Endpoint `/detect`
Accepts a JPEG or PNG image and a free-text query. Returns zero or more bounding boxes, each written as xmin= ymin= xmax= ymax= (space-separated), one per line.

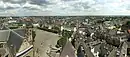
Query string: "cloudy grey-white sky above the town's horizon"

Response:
xmin=0 ymin=0 xmax=130 ymax=16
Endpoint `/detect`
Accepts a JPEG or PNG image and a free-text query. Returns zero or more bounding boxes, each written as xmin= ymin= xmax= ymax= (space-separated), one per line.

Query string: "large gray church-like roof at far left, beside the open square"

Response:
xmin=0 ymin=29 xmax=25 ymax=53
